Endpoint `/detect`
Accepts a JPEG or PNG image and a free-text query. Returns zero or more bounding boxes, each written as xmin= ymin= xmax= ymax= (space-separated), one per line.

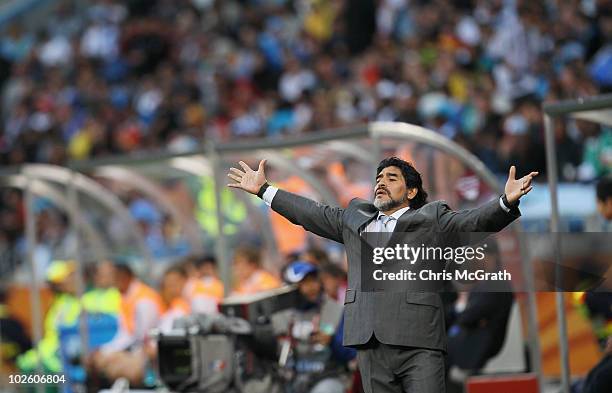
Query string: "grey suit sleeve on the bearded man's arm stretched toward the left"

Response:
xmin=272 ymin=190 xmax=344 ymax=243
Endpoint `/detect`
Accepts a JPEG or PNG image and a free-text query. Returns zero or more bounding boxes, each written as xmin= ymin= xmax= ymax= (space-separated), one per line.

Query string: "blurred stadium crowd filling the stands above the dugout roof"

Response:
xmin=0 ymin=0 xmax=612 ymax=181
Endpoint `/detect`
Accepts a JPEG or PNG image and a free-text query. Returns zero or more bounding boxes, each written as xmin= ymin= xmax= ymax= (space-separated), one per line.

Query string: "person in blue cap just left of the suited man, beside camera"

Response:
xmin=272 ymin=261 xmax=355 ymax=393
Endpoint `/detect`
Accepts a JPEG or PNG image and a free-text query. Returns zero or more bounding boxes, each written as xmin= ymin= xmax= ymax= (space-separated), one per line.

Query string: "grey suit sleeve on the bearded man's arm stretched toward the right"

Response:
xmin=437 ymin=199 xmax=521 ymax=232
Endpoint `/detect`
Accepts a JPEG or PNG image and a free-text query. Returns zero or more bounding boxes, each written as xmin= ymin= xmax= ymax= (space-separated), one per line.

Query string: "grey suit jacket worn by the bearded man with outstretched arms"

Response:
xmin=272 ymin=190 xmax=520 ymax=350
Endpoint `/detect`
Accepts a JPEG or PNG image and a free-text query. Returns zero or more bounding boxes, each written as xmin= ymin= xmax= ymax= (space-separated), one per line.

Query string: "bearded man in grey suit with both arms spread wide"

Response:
xmin=228 ymin=157 xmax=538 ymax=393
